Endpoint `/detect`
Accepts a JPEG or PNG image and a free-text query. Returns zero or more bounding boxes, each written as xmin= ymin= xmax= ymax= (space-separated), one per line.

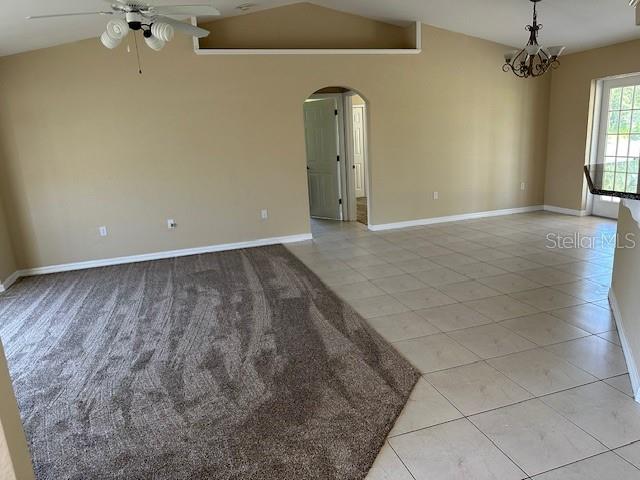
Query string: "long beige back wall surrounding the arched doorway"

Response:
xmin=0 ymin=6 xmax=550 ymax=268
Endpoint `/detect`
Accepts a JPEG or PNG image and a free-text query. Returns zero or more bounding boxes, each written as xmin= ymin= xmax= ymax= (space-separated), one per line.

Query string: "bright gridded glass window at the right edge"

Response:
xmin=595 ymin=75 xmax=640 ymax=195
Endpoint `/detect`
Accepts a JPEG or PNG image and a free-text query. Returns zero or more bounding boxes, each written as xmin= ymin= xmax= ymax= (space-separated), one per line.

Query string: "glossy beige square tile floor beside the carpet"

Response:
xmin=290 ymin=212 xmax=640 ymax=480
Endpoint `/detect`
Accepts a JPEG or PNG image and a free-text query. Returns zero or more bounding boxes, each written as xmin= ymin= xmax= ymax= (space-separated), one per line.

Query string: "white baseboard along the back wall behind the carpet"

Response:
xmin=0 ymin=233 xmax=313 ymax=292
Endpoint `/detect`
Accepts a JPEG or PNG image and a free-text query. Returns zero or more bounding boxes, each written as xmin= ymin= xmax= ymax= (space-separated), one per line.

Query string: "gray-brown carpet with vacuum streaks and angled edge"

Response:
xmin=0 ymin=246 xmax=418 ymax=480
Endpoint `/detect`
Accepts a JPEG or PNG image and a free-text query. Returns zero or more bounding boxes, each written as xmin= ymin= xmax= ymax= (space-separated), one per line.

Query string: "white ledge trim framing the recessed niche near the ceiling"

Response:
xmin=191 ymin=17 xmax=422 ymax=55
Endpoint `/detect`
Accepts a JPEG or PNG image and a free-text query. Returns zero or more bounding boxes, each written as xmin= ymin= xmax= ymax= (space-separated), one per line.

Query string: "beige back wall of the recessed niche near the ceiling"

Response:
xmin=200 ymin=3 xmax=416 ymax=49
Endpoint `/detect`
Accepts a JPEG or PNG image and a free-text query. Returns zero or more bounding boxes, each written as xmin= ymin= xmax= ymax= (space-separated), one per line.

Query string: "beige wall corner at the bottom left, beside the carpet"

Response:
xmin=0 ymin=342 xmax=35 ymax=480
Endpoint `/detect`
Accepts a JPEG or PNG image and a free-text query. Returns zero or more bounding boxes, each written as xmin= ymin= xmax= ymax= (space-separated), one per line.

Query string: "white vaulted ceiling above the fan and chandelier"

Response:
xmin=0 ymin=0 xmax=640 ymax=55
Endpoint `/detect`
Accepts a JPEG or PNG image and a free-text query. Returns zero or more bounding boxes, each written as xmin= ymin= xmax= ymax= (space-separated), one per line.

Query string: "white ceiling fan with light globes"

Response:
xmin=27 ymin=0 xmax=220 ymax=50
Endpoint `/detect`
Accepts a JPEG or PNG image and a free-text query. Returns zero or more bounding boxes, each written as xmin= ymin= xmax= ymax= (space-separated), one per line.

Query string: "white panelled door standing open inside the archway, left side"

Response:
xmin=304 ymin=98 xmax=342 ymax=220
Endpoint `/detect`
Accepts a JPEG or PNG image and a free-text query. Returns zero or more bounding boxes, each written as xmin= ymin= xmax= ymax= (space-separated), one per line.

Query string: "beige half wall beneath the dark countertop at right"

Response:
xmin=611 ymin=205 xmax=640 ymax=393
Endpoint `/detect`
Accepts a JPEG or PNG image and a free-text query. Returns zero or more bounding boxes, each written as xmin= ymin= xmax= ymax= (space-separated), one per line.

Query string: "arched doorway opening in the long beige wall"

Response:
xmin=304 ymin=87 xmax=371 ymax=226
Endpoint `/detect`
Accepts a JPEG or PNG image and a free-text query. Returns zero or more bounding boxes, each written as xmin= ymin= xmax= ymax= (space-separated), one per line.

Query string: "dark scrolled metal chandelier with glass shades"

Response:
xmin=502 ymin=0 xmax=565 ymax=78
